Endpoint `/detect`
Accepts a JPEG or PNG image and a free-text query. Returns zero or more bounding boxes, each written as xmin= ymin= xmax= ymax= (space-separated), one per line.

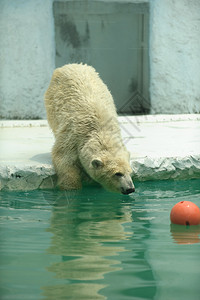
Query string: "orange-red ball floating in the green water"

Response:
xmin=170 ymin=201 xmax=200 ymax=225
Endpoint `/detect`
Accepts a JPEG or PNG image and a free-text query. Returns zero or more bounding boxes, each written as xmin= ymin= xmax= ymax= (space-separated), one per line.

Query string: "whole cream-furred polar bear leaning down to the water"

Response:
xmin=45 ymin=64 xmax=135 ymax=194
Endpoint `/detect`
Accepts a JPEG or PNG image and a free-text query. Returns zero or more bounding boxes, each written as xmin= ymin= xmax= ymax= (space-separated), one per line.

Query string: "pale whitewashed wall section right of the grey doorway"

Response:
xmin=150 ymin=0 xmax=200 ymax=114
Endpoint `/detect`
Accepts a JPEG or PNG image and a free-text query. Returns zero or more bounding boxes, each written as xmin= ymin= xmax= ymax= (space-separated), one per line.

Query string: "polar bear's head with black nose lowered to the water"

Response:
xmin=87 ymin=155 xmax=135 ymax=195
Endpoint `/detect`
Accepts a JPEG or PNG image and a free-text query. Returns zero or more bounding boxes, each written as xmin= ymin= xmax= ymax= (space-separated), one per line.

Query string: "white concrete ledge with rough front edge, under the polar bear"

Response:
xmin=0 ymin=114 xmax=200 ymax=190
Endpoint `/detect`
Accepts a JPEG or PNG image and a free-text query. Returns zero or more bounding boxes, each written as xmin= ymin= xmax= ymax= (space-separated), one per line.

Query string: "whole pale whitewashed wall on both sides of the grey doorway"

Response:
xmin=0 ymin=0 xmax=200 ymax=119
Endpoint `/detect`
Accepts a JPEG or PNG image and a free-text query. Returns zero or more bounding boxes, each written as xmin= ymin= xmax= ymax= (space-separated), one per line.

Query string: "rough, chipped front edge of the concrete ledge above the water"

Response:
xmin=0 ymin=156 xmax=200 ymax=191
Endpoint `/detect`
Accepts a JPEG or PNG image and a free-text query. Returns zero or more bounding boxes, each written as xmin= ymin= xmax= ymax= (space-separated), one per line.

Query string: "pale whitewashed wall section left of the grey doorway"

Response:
xmin=0 ymin=0 xmax=55 ymax=119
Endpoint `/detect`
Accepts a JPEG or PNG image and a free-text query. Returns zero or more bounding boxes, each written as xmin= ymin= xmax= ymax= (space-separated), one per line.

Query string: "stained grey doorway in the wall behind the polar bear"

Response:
xmin=53 ymin=0 xmax=150 ymax=114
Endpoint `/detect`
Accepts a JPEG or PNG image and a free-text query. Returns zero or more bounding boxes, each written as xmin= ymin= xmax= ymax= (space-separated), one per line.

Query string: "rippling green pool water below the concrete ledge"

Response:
xmin=0 ymin=180 xmax=200 ymax=300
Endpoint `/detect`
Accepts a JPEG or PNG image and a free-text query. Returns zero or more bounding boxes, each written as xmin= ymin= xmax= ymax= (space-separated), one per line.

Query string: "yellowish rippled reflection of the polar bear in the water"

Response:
xmin=43 ymin=189 xmax=132 ymax=300
